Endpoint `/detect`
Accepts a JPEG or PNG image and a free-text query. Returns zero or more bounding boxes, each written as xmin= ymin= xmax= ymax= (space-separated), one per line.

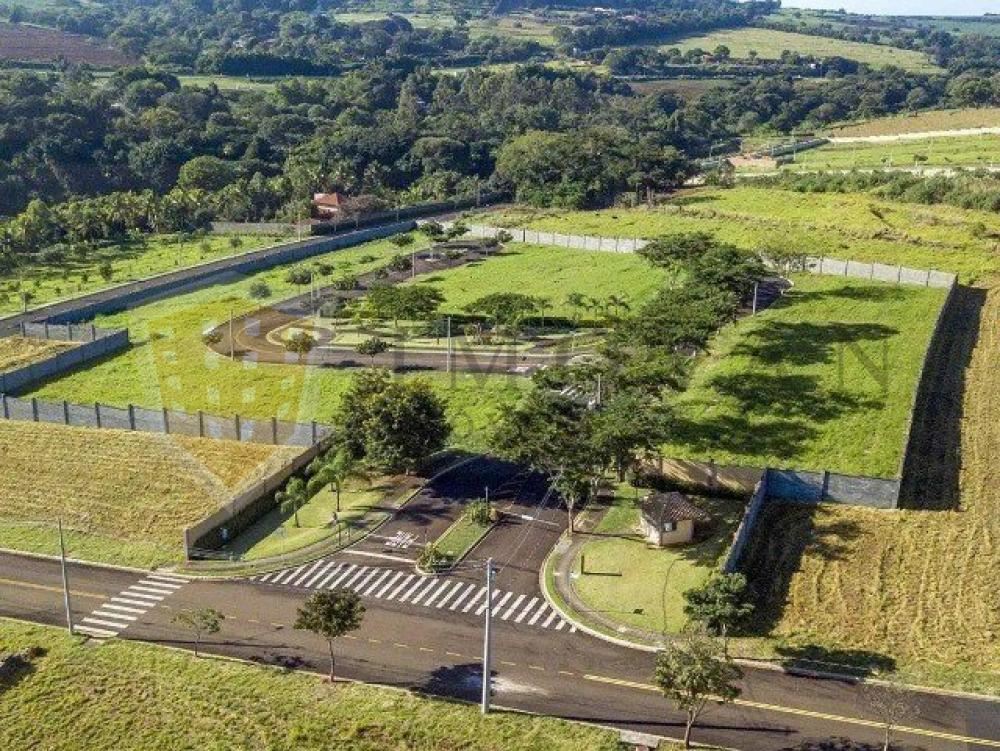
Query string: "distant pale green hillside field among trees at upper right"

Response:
xmin=660 ymin=28 xmax=940 ymax=73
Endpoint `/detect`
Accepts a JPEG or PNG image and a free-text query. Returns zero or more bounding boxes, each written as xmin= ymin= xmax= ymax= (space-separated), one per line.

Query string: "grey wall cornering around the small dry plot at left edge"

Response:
xmin=0 ymin=323 xmax=129 ymax=393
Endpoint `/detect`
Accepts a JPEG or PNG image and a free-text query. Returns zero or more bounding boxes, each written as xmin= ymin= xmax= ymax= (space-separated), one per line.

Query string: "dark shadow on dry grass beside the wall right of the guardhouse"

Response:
xmin=740 ymin=503 xmax=861 ymax=636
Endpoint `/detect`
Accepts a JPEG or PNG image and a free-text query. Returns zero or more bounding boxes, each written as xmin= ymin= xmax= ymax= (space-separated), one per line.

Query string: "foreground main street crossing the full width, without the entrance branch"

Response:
xmin=0 ymin=554 xmax=1000 ymax=751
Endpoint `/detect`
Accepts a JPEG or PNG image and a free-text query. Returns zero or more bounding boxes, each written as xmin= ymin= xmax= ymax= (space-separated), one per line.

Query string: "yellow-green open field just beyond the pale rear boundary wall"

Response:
xmin=477 ymin=186 xmax=1000 ymax=283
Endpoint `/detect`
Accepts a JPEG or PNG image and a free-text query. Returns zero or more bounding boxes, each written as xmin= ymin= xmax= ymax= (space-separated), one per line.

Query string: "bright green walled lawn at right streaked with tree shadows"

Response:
xmin=663 ymin=274 xmax=945 ymax=477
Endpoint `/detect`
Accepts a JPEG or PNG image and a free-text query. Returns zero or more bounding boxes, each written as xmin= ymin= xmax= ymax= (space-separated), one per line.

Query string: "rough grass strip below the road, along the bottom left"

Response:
xmin=0 ymin=620 xmax=618 ymax=751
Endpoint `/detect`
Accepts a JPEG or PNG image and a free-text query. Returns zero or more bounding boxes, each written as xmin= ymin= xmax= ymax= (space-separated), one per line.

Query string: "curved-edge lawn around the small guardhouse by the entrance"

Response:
xmin=572 ymin=485 xmax=744 ymax=633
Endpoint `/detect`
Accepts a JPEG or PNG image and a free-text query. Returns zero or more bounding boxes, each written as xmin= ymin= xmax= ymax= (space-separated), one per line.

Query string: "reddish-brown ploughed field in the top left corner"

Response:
xmin=0 ymin=23 xmax=135 ymax=68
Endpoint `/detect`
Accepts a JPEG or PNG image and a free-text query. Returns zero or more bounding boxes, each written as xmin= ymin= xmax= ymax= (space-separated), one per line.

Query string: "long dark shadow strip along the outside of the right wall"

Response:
xmin=900 ymin=287 xmax=986 ymax=511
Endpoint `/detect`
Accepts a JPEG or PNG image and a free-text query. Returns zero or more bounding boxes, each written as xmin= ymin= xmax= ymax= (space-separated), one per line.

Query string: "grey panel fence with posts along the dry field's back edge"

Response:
xmin=0 ymin=394 xmax=333 ymax=447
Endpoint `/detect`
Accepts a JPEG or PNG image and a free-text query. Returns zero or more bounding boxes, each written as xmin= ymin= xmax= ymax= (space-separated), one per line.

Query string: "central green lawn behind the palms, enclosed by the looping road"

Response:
xmin=406 ymin=243 xmax=667 ymax=319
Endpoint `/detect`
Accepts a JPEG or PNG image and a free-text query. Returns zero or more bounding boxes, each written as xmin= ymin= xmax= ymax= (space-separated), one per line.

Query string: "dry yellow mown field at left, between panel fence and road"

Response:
xmin=0 ymin=421 xmax=301 ymax=567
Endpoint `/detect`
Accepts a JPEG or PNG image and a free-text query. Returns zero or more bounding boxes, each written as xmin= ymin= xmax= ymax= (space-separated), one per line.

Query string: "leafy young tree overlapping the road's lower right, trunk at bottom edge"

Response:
xmin=653 ymin=633 xmax=743 ymax=748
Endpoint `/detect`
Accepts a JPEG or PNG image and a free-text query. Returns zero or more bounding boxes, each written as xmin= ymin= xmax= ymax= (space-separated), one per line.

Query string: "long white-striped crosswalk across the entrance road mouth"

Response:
xmin=252 ymin=558 xmax=576 ymax=634
